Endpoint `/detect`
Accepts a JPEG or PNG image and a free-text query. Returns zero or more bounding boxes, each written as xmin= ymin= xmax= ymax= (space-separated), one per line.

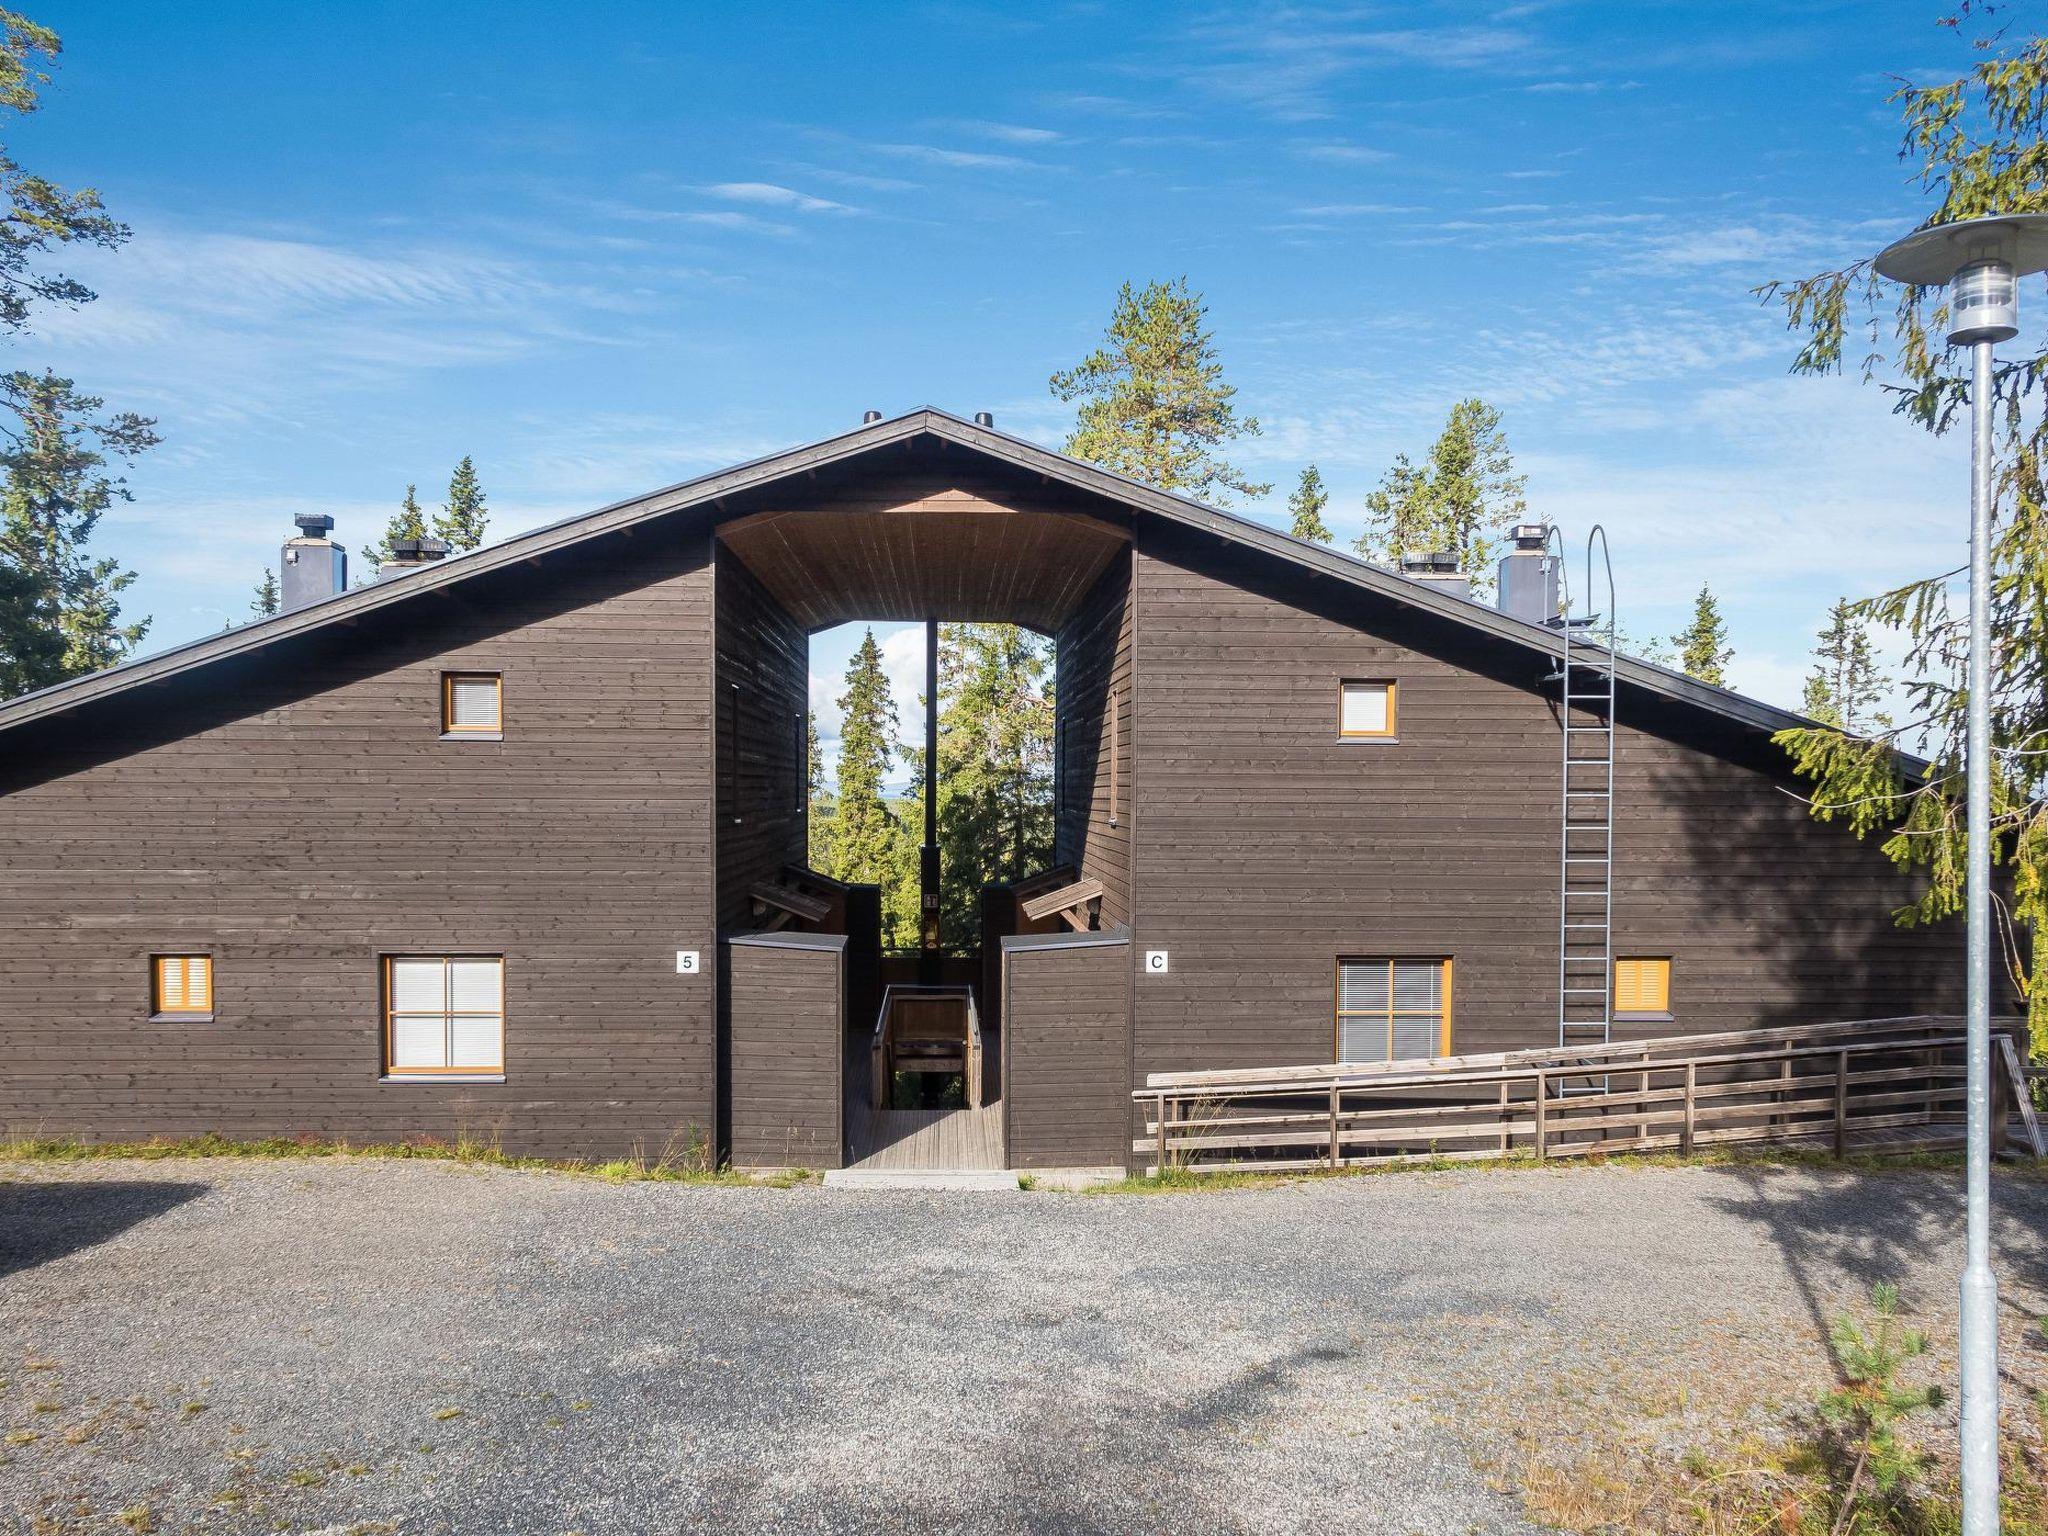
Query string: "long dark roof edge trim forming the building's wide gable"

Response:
xmin=0 ymin=406 xmax=1812 ymax=745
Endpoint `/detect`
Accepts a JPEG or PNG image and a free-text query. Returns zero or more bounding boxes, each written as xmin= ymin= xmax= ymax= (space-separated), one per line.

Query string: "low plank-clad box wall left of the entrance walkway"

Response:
xmin=725 ymin=934 xmax=846 ymax=1167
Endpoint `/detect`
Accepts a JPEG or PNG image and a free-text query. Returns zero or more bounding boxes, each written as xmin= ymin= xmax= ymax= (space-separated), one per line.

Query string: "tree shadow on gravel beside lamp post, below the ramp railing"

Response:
xmin=1712 ymin=1167 xmax=2048 ymax=1368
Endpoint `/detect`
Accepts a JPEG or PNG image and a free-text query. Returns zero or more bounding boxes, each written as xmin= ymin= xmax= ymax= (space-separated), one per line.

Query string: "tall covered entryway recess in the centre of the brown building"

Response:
xmin=715 ymin=436 xmax=1130 ymax=1171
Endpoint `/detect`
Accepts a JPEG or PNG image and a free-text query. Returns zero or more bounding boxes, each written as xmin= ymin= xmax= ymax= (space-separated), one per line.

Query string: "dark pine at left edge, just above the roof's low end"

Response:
xmin=0 ymin=373 xmax=158 ymax=692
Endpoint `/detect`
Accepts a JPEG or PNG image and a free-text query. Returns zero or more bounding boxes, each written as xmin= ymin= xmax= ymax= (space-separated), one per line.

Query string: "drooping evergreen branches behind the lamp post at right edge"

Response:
xmin=1757 ymin=4 xmax=2048 ymax=1057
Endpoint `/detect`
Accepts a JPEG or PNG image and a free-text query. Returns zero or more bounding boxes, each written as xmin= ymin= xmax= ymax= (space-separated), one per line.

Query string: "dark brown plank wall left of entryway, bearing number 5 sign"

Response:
xmin=0 ymin=524 xmax=717 ymax=1157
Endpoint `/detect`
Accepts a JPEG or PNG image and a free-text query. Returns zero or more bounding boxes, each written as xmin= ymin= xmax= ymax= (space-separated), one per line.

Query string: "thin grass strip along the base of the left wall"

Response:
xmin=0 ymin=1133 xmax=815 ymax=1190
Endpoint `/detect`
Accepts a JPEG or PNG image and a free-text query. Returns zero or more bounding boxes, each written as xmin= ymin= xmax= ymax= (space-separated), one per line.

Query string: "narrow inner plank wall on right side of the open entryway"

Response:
xmin=1053 ymin=555 xmax=1135 ymax=926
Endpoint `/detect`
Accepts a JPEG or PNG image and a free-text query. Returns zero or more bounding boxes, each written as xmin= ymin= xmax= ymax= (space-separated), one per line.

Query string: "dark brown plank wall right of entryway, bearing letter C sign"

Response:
xmin=1133 ymin=524 xmax=1962 ymax=1105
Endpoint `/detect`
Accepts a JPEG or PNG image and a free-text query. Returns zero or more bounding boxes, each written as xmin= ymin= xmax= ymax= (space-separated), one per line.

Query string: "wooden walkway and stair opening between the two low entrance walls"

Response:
xmin=846 ymin=985 xmax=1004 ymax=1169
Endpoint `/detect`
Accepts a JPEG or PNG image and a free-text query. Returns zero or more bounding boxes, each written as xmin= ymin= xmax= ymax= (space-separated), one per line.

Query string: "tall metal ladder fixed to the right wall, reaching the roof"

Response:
xmin=1546 ymin=524 xmax=1616 ymax=1094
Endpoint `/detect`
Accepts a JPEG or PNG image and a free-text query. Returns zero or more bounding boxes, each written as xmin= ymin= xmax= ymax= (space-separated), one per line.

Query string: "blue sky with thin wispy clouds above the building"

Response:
xmin=12 ymin=0 xmax=1998 ymax=770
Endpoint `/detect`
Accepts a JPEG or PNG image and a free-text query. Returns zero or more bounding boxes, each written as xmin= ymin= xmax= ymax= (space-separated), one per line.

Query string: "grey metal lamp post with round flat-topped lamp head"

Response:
xmin=1876 ymin=213 xmax=2048 ymax=1536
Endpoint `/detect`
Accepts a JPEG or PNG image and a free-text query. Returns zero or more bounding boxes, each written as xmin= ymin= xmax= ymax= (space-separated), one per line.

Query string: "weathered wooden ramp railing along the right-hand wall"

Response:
xmin=1133 ymin=1016 xmax=2042 ymax=1171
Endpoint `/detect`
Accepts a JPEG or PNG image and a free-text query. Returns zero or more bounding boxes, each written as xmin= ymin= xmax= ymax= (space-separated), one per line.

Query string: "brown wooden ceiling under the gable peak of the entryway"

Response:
xmin=719 ymin=473 xmax=1130 ymax=633
